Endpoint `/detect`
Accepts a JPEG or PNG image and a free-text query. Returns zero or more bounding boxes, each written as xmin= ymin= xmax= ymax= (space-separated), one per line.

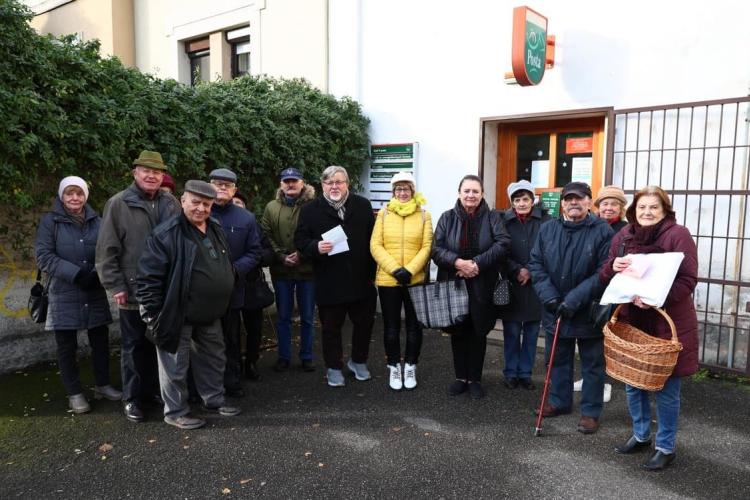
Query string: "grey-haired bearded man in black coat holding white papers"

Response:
xmin=294 ymin=166 xmax=377 ymax=387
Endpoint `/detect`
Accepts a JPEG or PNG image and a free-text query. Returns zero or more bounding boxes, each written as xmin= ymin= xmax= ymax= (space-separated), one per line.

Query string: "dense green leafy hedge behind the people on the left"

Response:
xmin=0 ymin=0 xmax=369 ymax=262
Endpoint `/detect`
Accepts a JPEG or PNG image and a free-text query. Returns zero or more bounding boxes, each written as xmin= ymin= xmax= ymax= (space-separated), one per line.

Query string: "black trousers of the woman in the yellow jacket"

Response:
xmin=378 ymin=286 xmax=422 ymax=365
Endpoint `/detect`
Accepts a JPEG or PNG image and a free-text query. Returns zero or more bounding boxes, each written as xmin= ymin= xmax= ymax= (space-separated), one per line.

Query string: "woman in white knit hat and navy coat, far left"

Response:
xmin=34 ymin=176 xmax=122 ymax=413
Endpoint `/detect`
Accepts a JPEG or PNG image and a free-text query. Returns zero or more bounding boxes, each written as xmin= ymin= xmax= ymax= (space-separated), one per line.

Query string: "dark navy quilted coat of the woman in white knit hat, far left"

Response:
xmin=34 ymin=199 xmax=112 ymax=330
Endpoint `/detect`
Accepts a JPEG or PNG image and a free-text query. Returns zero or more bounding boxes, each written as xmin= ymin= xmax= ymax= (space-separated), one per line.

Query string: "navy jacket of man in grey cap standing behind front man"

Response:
xmin=211 ymin=202 xmax=263 ymax=309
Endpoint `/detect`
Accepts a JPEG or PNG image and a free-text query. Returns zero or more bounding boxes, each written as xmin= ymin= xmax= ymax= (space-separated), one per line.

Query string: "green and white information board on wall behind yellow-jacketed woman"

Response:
xmin=370 ymin=142 xmax=419 ymax=211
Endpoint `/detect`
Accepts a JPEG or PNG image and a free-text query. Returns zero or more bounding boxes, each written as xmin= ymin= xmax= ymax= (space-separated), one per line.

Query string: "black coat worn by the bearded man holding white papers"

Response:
xmin=294 ymin=192 xmax=377 ymax=306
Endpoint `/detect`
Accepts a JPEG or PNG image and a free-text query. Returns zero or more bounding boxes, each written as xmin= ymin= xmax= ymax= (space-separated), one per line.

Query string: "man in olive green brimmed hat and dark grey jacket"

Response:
xmin=96 ymin=151 xmax=180 ymax=422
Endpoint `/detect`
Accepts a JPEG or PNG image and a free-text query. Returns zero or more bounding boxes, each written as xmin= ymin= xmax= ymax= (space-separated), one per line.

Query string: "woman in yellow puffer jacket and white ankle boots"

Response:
xmin=370 ymin=172 xmax=432 ymax=391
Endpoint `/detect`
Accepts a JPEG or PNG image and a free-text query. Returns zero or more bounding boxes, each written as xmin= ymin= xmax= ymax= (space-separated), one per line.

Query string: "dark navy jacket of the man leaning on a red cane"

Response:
xmin=529 ymin=212 xmax=614 ymax=338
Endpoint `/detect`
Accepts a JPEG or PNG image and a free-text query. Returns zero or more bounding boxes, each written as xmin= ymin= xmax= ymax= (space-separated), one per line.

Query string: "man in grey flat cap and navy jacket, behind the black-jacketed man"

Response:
xmin=208 ymin=168 xmax=263 ymax=398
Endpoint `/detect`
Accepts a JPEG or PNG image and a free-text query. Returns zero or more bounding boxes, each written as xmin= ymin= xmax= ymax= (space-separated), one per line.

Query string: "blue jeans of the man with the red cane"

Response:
xmin=546 ymin=333 xmax=605 ymax=418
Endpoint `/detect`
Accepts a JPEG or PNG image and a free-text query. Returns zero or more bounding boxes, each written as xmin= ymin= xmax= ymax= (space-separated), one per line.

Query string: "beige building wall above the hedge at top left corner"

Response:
xmin=31 ymin=0 xmax=136 ymax=66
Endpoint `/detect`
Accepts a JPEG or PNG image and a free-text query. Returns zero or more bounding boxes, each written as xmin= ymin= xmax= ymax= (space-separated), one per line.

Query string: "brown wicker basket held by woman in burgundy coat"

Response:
xmin=603 ymin=304 xmax=682 ymax=391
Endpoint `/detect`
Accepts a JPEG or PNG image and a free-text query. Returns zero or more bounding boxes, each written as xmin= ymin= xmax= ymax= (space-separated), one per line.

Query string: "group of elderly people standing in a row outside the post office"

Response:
xmin=35 ymin=159 xmax=698 ymax=470
